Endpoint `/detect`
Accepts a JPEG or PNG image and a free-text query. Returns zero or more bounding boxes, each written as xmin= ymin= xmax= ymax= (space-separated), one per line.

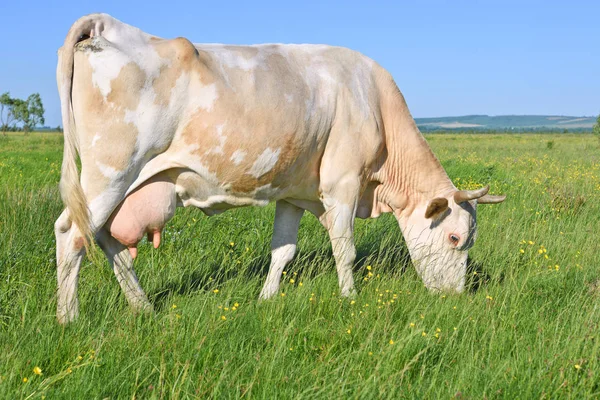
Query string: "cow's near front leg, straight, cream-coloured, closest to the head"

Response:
xmin=319 ymin=177 xmax=359 ymax=297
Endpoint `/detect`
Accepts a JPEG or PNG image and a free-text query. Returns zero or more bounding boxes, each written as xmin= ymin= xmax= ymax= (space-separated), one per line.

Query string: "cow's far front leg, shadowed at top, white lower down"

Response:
xmin=260 ymin=200 xmax=304 ymax=299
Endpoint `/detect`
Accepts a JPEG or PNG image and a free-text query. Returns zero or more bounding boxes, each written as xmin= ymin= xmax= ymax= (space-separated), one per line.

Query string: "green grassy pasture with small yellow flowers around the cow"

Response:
xmin=0 ymin=133 xmax=600 ymax=399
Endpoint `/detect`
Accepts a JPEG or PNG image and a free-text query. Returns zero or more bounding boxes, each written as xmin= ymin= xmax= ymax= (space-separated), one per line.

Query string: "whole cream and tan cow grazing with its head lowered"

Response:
xmin=55 ymin=14 xmax=504 ymax=323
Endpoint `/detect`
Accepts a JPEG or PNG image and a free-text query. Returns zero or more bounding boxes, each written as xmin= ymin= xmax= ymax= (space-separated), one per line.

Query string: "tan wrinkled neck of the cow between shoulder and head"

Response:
xmin=378 ymin=92 xmax=455 ymax=214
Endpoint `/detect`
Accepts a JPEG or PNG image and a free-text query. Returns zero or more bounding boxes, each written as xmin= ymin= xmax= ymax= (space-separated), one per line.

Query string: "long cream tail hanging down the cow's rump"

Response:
xmin=56 ymin=14 xmax=103 ymax=241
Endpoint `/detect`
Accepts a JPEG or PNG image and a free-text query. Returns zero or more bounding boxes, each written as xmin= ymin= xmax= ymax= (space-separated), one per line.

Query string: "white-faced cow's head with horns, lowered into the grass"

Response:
xmin=397 ymin=186 xmax=506 ymax=293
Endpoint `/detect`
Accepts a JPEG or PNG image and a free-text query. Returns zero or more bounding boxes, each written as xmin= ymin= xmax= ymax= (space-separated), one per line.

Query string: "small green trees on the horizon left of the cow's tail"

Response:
xmin=0 ymin=92 xmax=45 ymax=136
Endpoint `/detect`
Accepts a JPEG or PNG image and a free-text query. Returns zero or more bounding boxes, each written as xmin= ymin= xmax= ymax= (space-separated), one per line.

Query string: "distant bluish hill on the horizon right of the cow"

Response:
xmin=415 ymin=115 xmax=596 ymax=131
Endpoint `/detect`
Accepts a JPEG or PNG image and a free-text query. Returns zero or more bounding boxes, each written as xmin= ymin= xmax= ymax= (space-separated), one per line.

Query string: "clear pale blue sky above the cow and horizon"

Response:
xmin=0 ymin=0 xmax=600 ymax=126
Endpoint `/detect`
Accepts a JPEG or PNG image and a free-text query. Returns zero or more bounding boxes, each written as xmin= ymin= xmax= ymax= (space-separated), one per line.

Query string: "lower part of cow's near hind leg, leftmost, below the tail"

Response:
xmin=54 ymin=210 xmax=85 ymax=324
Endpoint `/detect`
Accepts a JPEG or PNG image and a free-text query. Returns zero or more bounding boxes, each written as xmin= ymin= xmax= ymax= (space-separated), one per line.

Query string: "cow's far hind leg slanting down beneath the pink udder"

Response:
xmin=96 ymin=228 xmax=154 ymax=312
